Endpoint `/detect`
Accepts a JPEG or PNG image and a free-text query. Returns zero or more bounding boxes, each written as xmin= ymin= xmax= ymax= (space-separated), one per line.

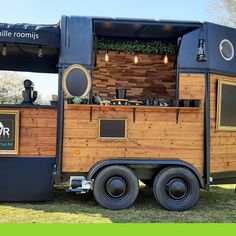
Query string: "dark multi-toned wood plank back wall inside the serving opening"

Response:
xmin=93 ymin=51 xmax=176 ymax=99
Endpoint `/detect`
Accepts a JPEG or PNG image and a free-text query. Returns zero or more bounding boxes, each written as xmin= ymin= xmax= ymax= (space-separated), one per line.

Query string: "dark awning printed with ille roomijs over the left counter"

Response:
xmin=0 ymin=24 xmax=60 ymax=73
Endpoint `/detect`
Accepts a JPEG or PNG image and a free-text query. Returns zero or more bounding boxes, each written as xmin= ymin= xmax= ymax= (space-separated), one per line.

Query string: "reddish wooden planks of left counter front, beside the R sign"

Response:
xmin=0 ymin=108 xmax=57 ymax=158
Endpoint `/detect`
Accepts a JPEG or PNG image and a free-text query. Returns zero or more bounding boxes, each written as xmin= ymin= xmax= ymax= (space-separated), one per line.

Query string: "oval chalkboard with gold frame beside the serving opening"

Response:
xmin=63 ymin=65 xmax=92 ymax=97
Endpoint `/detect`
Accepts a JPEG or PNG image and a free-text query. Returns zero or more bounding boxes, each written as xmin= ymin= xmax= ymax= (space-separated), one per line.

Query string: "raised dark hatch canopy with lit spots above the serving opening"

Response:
xmin=93 ymin=18 xmax=203 ymax=40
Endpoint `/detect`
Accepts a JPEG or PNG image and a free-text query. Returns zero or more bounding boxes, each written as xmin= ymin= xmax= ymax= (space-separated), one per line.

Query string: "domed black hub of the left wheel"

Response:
xmin=105 ymin=177 xmax=127 ymax=198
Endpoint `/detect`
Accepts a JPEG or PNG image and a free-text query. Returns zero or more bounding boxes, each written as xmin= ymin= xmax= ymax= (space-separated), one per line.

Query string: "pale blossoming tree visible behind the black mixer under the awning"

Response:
xmin=0 ymin=72 xmax=49 ymax=105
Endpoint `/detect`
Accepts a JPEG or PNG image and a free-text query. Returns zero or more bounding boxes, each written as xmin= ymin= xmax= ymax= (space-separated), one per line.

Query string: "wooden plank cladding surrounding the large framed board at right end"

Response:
xmin=210 ymin=74 xmax=236 ymax=173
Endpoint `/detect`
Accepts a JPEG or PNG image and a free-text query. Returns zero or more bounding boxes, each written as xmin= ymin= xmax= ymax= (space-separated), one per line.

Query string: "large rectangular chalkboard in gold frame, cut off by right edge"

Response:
xmin=217 ymin=79 xmax=236 ymax=131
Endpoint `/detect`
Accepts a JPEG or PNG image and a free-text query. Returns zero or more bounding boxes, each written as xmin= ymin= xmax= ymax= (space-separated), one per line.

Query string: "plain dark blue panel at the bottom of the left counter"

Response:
xmin=0 ymin=157 xmax=55 ymax=201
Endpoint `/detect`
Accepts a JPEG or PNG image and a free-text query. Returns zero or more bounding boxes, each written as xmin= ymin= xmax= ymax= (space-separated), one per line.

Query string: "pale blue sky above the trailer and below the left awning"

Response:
xmin=0 ymin=0 xmax=214 ymax=98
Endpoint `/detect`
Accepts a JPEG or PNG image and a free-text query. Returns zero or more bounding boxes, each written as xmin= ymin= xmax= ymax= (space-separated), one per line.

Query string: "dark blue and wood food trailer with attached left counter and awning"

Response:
xmin=0 ymin=16 xmax=236 ymax=211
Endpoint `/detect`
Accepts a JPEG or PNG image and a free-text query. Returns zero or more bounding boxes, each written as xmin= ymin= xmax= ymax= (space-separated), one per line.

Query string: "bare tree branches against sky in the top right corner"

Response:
xmin=208 ymin=0 xmax=236 ymax=27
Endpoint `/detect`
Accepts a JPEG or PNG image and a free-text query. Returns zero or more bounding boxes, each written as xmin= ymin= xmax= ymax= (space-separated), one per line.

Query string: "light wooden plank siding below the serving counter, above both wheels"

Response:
xmin=62 ymin=71 xmax=205 ymax=173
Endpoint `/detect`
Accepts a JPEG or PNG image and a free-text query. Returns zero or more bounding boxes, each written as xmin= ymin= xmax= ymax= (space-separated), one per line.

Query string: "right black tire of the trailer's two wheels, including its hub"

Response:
xmin=153 ymin=167 xmax=200 ymax=211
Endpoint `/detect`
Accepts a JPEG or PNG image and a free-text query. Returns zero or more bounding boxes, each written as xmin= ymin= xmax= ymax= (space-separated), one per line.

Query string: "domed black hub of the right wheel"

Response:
xmin=166 ymin=179 xmax=188 ymax=200
